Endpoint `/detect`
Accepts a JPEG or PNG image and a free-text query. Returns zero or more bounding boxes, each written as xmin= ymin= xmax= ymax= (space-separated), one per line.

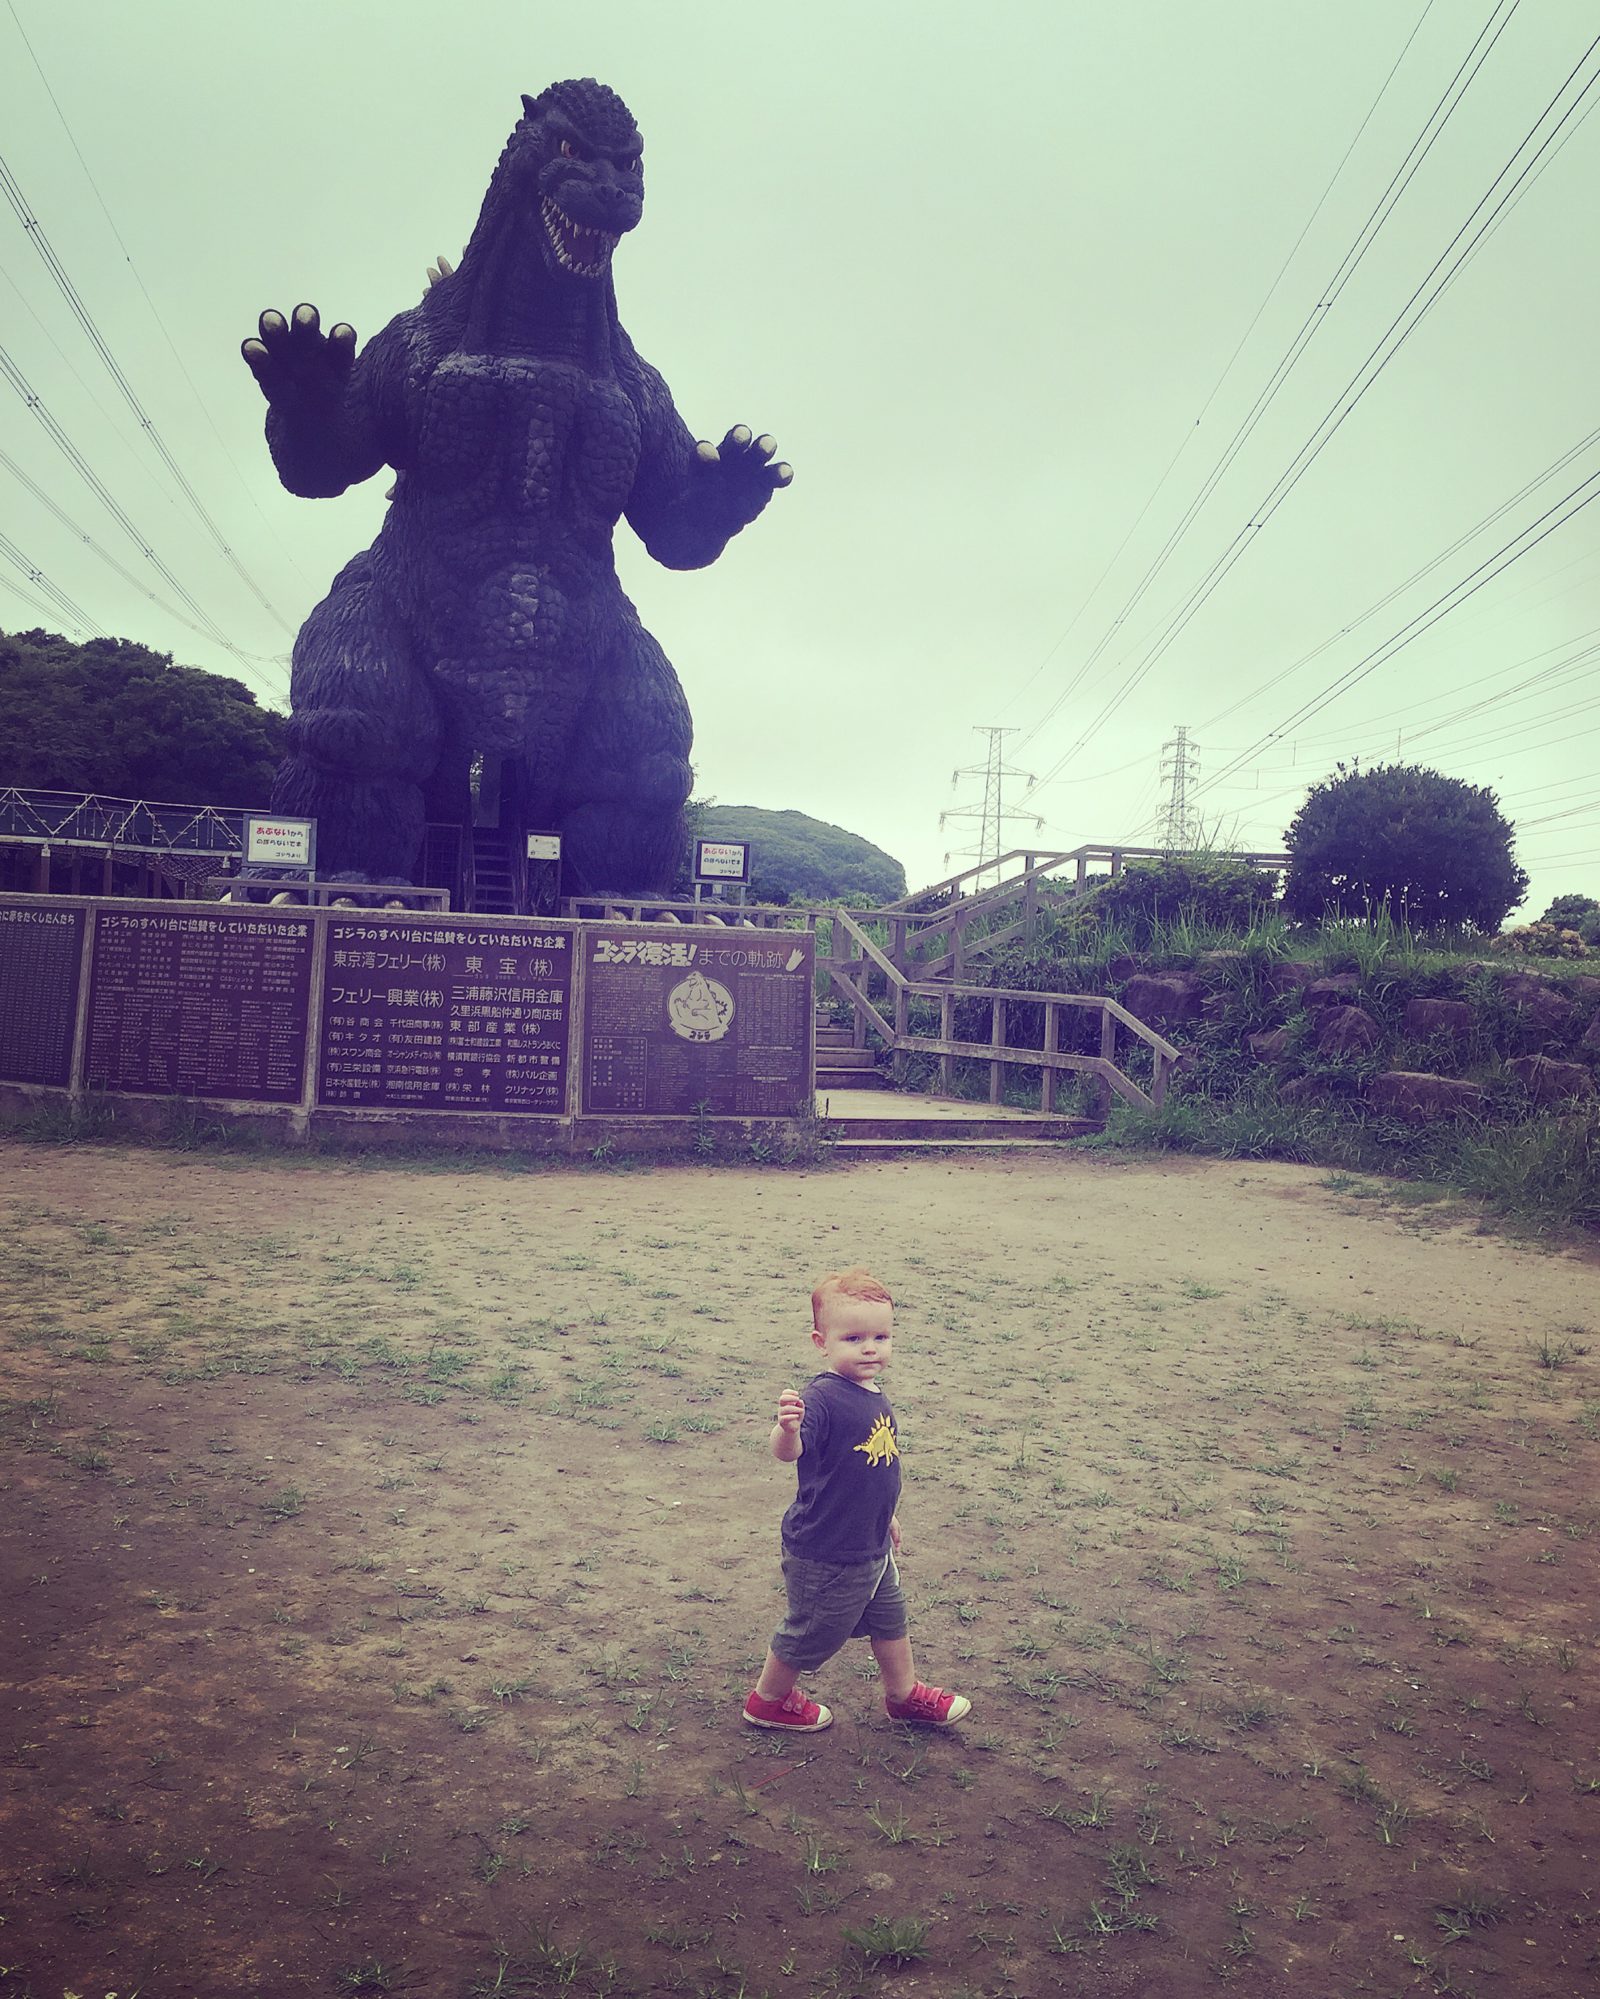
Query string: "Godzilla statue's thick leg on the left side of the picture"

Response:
xmin=272 ymin=554 xmax=440 ymax=880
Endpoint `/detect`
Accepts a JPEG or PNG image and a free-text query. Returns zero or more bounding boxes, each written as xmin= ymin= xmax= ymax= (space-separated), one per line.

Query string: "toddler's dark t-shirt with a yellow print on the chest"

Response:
xmin=784 ymin=1373 xmax=900 ymax=1563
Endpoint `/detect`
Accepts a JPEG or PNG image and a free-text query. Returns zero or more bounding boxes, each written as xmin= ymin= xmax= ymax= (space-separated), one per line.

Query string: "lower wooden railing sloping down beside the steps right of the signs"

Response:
xmin=818 ymin=910 xmax=1180 ymax=1113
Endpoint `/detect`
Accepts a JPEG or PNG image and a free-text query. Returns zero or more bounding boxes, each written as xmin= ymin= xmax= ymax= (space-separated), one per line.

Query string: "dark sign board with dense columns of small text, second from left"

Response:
xmin=84 ymin=904 xmax=312 ymax=1103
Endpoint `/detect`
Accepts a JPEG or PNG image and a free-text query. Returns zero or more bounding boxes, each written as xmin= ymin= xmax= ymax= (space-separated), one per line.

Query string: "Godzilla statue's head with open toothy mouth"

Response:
xmin=506 ymin=76 xmax=644 ymax=280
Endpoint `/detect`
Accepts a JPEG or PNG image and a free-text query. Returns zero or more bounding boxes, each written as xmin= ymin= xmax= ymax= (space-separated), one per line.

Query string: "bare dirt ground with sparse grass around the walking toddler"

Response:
xmin=0 ymin=1143 xmax=1600 ymax=1999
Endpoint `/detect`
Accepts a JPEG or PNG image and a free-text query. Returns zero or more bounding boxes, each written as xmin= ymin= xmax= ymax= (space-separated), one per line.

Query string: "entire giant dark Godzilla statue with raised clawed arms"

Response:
xmin=242 ymin=78 xmax=792 ymax=894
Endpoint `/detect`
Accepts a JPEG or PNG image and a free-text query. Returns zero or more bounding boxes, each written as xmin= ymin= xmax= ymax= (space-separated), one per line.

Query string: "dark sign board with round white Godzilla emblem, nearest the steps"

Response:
xmin=582 ymin=926 xmax=814 ymax=1117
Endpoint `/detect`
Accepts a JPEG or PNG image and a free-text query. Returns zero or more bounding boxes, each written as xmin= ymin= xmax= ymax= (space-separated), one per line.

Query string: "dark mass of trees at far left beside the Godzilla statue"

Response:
xmin=0 ymin=630 xmax=288 ymax=806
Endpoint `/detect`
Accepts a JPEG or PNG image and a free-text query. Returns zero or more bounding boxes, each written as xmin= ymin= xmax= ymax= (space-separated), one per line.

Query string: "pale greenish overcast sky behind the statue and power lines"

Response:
xmin=0 ymin=0 xmax=1600 ymax=914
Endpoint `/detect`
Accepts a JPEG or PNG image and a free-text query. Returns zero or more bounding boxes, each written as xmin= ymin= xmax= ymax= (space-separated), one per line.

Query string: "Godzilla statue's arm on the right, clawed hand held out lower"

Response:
xmin=618 ymin=328 xmax=794 ymax=570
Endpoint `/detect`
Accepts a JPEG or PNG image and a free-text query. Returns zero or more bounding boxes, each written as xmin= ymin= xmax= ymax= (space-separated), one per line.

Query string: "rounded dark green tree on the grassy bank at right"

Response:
xmin=1284 ymin=764 xmax=1528 ymax=932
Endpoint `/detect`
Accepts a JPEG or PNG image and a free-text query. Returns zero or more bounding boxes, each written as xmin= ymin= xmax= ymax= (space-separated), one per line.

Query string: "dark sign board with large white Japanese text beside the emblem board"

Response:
xmin=318 ymin=920 xmax=572 ymax=1115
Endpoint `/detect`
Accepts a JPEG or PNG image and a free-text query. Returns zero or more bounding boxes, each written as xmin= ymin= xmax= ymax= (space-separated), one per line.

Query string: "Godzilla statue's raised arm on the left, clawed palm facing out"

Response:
xmin=242 ymin=306 xmax=406 ymax=500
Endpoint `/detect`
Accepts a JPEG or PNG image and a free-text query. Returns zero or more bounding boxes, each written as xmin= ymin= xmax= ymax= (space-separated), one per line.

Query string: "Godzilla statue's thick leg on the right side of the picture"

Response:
xmin=558 ymin=600 xmax=692 ymax=896
